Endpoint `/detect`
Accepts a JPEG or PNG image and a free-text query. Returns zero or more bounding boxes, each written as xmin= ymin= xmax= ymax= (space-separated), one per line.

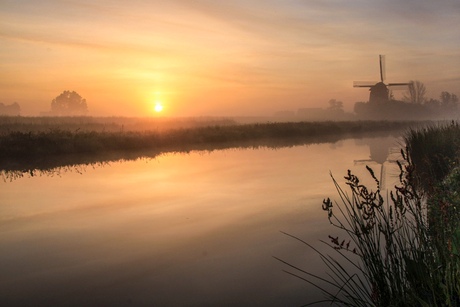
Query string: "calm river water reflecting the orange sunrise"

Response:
xmin=0 ymin=138 xmax=397 ymax=306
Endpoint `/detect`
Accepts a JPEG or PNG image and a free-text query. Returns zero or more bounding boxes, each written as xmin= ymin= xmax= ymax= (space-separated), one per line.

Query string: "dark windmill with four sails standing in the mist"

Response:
xmin=353 ymin=55 xmax=411 ymax=103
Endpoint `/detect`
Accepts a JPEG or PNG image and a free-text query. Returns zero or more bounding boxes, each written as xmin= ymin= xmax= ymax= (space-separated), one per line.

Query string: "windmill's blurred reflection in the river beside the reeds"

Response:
xmin=354 ymin=137 xmax=401 ymax=190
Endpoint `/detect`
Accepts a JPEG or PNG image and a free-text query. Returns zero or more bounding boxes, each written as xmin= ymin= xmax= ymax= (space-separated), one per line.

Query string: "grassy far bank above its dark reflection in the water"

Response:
xmin=0 ymin=121 xmax=424 ymax=159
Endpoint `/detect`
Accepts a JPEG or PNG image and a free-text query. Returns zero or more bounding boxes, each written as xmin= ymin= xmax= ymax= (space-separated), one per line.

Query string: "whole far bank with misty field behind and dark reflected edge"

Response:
xmin=0 ymin=117 xmax=430 ymax=177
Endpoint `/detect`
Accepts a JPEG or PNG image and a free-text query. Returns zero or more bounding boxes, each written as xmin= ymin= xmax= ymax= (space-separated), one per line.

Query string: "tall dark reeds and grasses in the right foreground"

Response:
xmin=282 ymin=123 xmax=460 ymax=306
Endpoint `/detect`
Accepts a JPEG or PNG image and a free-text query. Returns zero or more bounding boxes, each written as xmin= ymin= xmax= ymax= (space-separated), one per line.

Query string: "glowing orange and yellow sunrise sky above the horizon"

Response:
xmin=0 ymin=0 xmax=460 ymax=116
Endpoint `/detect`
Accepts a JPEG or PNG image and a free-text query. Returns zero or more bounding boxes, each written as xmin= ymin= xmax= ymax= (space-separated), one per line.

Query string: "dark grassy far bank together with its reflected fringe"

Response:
xmin=0 ymin=121 xmax=430 ymax=172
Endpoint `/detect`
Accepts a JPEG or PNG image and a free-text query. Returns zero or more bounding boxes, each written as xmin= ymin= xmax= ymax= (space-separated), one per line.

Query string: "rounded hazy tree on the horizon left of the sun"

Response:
xmin=51 ymin=91 xmax=88 ymax=116
